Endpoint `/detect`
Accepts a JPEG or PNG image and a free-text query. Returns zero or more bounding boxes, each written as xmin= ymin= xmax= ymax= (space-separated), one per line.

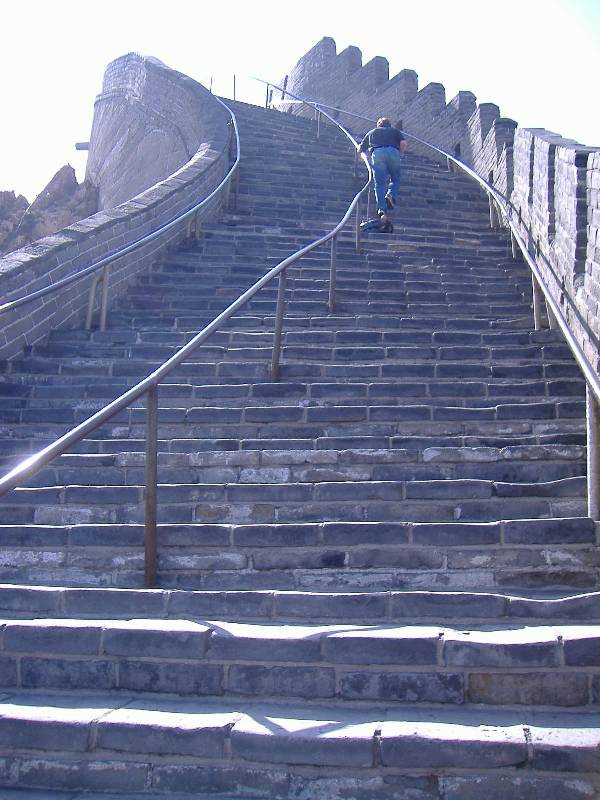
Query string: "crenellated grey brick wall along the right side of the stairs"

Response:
xmin=283 ymin=37 xmax=600 ymax=382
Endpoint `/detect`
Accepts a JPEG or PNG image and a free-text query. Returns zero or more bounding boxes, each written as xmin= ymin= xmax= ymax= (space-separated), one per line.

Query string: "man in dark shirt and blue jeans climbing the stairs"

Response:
xmin=359 ymin=117 xmax=406 ymax=221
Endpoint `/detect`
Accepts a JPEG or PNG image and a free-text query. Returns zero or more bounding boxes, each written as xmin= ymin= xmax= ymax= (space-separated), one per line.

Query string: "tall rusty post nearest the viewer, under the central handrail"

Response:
xmin=144 ymin=385 xmax=158 ymax=589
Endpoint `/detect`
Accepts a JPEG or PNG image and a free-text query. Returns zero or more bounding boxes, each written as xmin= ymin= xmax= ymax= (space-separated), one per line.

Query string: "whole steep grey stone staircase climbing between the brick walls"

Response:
xmin=0 ymin=103 xmax=600 ymax=800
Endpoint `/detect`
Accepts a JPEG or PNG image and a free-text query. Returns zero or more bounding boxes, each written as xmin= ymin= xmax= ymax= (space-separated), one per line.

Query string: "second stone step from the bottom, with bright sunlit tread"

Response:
xmin=0 ymin=618 xmax=600 ymax=708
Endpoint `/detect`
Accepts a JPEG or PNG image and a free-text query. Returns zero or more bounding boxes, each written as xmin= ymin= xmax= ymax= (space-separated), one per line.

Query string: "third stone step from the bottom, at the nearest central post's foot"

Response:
xmin=0 ymin=584 xmax=600 ymax=627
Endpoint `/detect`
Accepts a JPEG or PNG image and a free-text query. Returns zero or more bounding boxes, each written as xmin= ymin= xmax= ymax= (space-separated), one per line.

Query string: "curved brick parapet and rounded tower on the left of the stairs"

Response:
xmin=0 ymin=55 xmax=229 ymax=358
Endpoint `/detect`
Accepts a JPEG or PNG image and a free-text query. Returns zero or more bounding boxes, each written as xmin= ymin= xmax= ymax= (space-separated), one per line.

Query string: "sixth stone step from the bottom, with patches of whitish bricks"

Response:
xmin=18 ymin=445 xmax=586 ymax=486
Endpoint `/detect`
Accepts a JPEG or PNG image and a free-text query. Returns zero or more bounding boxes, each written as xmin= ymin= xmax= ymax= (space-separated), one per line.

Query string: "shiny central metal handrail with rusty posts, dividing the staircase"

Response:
xmin=0 ymin=89 xmax=372 ymax=587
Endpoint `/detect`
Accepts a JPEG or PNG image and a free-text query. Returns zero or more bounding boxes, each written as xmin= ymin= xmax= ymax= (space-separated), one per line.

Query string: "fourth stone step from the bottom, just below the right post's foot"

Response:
xmin=0 ymin=507 xmax=600 ymax=592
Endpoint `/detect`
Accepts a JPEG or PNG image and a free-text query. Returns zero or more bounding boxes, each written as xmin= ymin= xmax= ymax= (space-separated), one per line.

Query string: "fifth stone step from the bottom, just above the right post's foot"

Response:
xmin=0 ymin=477 xmax=587 ymax=524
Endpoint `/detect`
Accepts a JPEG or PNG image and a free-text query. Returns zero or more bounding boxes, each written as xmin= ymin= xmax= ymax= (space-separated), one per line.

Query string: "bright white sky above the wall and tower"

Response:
xmin=0 ymin=0 xmax=600 ymax=202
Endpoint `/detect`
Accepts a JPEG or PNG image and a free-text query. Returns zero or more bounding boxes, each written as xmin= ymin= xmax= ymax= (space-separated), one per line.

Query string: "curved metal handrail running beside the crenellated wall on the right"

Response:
xmin=266 ymin=83 xmax=600 ymax=402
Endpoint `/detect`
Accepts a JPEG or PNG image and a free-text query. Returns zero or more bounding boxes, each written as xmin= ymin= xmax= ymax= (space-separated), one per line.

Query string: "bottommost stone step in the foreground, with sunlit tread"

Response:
xmin=0 ymin=692 xmax=599 ymax=800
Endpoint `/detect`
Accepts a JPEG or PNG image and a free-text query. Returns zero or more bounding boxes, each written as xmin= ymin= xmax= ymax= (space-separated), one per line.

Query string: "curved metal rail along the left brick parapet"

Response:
xmin=0 ymin=97 xmax=240 ymax=314
